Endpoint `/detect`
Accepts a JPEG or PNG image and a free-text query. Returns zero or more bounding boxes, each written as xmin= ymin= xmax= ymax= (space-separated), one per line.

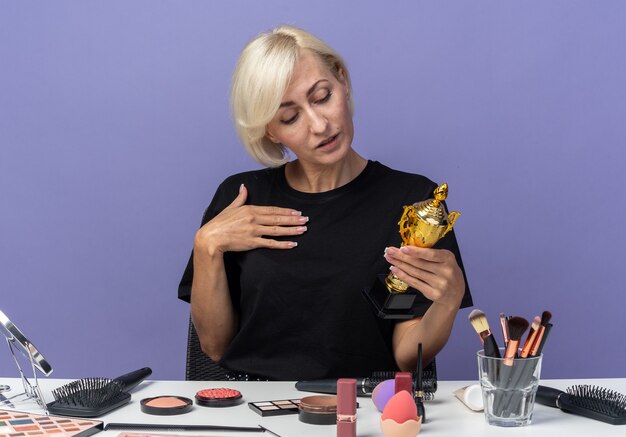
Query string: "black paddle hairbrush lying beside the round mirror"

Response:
xmin=47 ymin=367 xmax=152 ymax=417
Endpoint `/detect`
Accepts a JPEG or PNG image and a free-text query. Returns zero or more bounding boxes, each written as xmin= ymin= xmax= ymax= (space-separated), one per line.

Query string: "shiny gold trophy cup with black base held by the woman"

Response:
xmin=364 ymin=184 xmax=461 ymax=319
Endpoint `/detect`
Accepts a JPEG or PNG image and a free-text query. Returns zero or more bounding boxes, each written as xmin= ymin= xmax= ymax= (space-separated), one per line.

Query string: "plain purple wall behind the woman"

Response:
xmin=0 ymin=0 xmax=626 ymax=379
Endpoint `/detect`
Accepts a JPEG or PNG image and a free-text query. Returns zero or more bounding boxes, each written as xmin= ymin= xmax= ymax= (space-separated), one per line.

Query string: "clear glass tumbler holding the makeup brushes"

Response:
xmin=477 ymin=350 xmax=541 ymax=427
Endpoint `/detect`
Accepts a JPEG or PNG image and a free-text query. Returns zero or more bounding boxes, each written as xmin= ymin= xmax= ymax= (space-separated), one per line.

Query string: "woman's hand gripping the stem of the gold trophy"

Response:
xmin=385 ymin=246 xmax=465 ymax=309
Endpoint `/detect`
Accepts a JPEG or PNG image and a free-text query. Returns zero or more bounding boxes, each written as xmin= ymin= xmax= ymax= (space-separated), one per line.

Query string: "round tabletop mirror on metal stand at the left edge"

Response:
xmin=0 ymin=311 xmax=52 ymax=409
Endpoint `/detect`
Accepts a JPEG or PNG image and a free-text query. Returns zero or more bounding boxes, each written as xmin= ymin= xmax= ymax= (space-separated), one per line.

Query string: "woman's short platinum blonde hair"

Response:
xmin=230 ymin=26 xmax=354 ymax=167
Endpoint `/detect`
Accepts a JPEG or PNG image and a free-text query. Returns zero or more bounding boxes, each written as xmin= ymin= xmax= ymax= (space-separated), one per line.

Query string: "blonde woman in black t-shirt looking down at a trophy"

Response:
xmin=179 ymin=26 xmax=472 ymax=380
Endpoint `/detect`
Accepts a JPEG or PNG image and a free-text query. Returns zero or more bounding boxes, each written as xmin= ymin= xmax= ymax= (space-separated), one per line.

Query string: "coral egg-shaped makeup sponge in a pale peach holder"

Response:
xmin=380 ymin=390 xmax=422 ymax=437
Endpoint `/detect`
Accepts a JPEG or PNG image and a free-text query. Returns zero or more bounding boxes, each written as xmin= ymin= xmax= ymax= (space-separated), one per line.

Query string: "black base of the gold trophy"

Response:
xmin=363 ymin=274 xmax=418 ymax=320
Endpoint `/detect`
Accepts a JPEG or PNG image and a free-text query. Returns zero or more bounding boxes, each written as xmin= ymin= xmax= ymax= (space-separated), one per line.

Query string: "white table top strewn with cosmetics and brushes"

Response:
xmin=0 ymin=378 xmax=626 ymax=437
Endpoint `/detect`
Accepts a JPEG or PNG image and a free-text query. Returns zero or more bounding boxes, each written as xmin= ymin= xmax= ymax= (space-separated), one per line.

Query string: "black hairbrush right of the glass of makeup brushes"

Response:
xmin=535 ymin=385 xmax=626 ymax=425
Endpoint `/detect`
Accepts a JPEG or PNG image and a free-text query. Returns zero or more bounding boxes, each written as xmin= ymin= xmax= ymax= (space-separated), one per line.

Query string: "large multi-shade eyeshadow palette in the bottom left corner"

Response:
xmin=0 ymin=410 xmax=103 ymax=437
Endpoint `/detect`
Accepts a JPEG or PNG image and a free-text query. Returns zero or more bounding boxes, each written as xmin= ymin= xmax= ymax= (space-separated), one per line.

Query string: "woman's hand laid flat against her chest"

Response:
xmin=194 ymin=184 xmax=309 ymax=256
